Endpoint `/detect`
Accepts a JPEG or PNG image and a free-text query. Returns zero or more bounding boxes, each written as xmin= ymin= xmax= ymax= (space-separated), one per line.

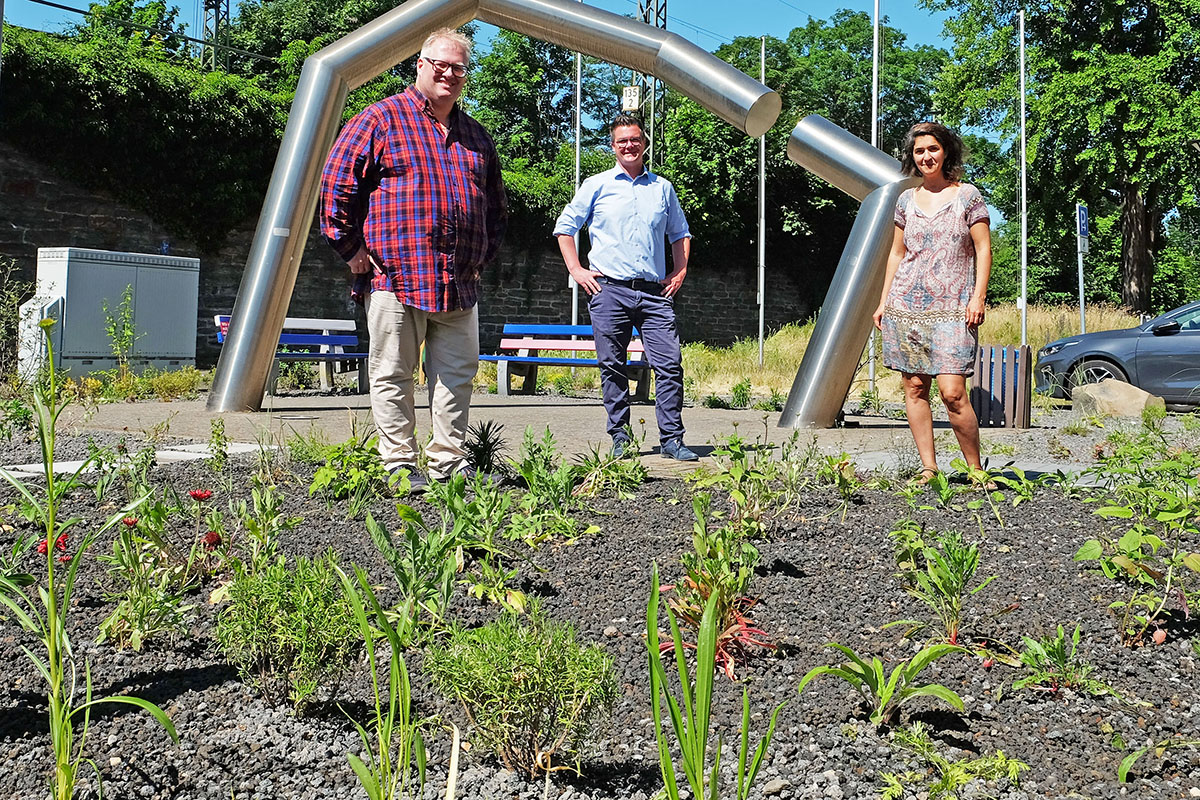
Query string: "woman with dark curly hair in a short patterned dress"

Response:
xmin=875 ymin=122 xmax=991 ymax=483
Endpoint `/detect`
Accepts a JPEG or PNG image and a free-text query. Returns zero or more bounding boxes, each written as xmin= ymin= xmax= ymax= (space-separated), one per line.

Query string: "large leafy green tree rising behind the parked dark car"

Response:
xmin=923 ymin=0 xmax=1200 ymax=311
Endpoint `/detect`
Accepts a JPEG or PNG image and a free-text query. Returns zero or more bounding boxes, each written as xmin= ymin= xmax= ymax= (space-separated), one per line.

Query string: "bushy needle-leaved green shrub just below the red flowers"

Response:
xmin=216 ymin=549 xmax=361 ymax=712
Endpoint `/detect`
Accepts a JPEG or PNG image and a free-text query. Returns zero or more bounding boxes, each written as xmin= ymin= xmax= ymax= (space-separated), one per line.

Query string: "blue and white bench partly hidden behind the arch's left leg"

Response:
xmin=212 ymin=314 xmax=368 ymax=395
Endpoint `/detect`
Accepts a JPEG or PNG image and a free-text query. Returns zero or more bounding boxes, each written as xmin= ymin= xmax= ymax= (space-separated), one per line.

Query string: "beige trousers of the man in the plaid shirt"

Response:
xmin=366 ymin=291 xmax=479 ymax=480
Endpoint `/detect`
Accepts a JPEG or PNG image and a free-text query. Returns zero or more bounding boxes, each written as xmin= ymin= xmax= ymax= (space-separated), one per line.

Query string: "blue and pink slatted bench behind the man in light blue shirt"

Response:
xmin=479 ymin=323 xmax=650 ymax=401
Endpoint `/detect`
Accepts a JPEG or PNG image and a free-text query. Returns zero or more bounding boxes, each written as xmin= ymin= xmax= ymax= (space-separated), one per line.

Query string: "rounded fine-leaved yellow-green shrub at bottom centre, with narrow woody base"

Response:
xmin=425 ymin=604 xmax=617 ymax=777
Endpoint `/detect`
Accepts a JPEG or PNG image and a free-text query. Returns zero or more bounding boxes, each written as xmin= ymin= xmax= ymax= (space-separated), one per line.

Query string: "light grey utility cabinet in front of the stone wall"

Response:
xmin=20 ymin=247 xmax=200 ymax=374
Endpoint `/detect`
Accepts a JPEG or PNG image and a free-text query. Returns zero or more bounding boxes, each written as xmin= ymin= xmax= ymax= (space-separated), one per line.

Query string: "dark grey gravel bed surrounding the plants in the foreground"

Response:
xmin=0 ymin=437 xmax=1200 ymax=800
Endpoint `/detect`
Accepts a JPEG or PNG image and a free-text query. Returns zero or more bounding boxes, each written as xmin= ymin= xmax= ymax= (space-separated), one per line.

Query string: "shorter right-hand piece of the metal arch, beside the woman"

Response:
xmin=779 ymin=114 xmax=920 ymax=428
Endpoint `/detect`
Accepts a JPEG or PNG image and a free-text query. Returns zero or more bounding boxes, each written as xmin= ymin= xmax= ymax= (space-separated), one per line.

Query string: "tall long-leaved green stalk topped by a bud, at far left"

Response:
xmin=0 ymin=319 xmax=179 ymax=800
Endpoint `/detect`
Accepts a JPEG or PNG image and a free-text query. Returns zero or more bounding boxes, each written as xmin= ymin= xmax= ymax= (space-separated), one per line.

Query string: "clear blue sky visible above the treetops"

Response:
xmin=4 ymin=0 xmax=944 ymax=50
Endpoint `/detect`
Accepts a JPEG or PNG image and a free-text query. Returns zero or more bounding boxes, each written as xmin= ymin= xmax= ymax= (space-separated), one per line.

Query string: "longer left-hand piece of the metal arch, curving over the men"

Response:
xmin=208 ymin=0 xmax=781 ymax=411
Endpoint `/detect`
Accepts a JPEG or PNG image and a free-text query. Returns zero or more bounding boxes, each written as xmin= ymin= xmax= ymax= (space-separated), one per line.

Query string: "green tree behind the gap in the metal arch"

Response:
xmin=664 ymin=11 xmax=946 ymax=284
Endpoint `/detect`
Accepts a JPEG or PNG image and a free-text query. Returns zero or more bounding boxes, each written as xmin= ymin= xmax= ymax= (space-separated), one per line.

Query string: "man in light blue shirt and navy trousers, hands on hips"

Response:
xmin=554 ymin=114 xmax=698 ymax=461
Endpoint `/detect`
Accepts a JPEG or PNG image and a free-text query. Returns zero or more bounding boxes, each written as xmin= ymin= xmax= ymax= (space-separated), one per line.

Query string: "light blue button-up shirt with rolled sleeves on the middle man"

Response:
xmin=554 ymin=167 xmax=691 ymax=281
